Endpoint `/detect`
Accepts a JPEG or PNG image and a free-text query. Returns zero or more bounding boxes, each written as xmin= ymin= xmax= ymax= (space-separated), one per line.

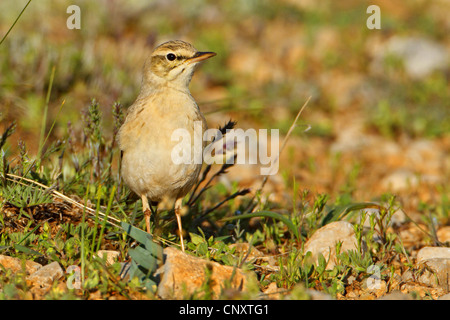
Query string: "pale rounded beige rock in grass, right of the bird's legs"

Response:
xmin=304 ymin=221 xmax=358 ymax=269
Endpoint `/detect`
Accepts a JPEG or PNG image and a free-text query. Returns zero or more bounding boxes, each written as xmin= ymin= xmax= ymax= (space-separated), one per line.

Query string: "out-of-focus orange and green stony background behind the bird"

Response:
xmin=0 ymin=0 xmax=450 ymax=212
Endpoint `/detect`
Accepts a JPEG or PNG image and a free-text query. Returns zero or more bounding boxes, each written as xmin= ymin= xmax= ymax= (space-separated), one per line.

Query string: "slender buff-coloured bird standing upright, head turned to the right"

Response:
xmin=118 ymin=40 xmax=216 ymax=252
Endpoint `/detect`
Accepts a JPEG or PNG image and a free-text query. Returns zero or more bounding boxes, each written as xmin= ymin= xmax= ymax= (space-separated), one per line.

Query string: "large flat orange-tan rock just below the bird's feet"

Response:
xmin=156 ymin=247 xmax=255 ymax=299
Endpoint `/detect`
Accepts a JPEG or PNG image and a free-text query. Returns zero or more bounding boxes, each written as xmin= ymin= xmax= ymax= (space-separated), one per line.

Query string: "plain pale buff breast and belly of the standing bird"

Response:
xmin=120 ymin=89 xmax=206 ymax=201
